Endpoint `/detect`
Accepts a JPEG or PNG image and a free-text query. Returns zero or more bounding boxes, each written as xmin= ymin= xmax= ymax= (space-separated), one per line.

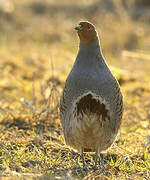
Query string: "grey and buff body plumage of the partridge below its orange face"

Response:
xmin=60 ymin=22 xmax=123 ymax=156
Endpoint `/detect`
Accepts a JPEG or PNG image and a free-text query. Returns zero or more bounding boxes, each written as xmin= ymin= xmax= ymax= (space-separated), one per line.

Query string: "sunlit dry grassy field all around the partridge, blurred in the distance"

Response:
xmin=0 ymin=0 xmax=150 ymax=180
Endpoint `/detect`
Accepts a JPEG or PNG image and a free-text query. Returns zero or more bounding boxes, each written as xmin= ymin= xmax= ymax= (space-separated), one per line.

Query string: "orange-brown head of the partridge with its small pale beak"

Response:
xmin=75 ymin=22 xmax=96 ymax=46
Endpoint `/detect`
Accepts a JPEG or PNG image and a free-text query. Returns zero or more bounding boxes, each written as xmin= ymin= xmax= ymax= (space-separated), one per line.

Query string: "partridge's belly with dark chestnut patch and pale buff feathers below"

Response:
xmin=67 ymin=92 xmax=110 ymax=151
